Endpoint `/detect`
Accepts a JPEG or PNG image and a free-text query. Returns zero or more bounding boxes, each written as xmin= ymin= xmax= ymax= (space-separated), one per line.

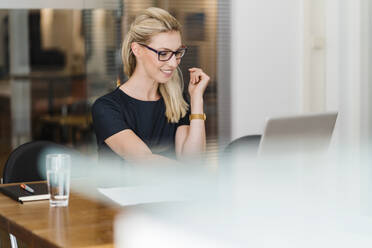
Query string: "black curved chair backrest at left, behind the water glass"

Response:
xmin=3 ymin=141 xmax=71 ymax=183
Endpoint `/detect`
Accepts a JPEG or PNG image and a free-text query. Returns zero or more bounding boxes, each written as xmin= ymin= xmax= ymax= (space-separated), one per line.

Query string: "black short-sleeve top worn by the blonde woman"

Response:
xmin=92 ymin=88 xmax=190 ymax=163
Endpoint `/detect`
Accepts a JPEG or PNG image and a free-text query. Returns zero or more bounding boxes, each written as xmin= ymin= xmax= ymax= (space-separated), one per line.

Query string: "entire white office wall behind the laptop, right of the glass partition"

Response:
xmin=228 ymin=0 xmax=372 ymax=147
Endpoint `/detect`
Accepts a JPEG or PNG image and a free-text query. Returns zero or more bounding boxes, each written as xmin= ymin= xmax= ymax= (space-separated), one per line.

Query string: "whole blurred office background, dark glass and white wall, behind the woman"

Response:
xmin=0 ymin=0 xmax=372 ymax=178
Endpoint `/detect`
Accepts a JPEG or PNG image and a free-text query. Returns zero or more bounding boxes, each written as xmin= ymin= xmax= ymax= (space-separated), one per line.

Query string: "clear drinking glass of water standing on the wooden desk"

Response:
xmin=46 ymin=154 xmax=71 ymax=207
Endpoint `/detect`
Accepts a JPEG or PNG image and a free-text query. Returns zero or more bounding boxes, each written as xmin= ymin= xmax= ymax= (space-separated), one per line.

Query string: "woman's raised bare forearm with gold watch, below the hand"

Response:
xmin=182 ymin=97 xmax=206 ymax=155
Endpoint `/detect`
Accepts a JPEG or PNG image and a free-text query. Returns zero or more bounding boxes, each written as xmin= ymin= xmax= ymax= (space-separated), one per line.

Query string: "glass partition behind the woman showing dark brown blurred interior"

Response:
xmin=0 ymin=0 xmax=221 ymax=175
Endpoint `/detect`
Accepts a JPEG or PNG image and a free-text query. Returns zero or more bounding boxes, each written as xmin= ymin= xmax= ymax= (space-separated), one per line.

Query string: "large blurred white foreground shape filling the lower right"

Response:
xmin=115 ymin=146 xmax=372 ymax=248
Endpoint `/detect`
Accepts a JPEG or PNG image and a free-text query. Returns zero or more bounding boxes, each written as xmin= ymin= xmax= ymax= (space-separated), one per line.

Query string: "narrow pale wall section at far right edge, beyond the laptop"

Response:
xmin=326 ymin=0 xmax=372 ymax=148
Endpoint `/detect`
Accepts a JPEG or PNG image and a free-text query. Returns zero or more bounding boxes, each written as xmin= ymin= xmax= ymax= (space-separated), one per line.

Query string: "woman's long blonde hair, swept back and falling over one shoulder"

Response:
xmin=121 ymin=7 xmax=189 ymax=123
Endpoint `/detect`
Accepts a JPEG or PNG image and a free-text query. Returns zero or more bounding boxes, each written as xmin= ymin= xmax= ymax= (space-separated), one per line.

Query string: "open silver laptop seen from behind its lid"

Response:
xmin=258 ymin=112 xmax=338 ymax=156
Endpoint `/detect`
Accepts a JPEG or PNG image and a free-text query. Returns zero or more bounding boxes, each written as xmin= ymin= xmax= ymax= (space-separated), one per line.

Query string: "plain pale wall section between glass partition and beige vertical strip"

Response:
xmin=230 ymin=0 xmax=303 ymax=138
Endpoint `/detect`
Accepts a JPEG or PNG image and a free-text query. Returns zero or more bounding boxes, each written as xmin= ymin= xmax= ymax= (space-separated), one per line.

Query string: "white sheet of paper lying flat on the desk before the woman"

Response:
xmin=98 ymin=186 xmax=187 ymax=206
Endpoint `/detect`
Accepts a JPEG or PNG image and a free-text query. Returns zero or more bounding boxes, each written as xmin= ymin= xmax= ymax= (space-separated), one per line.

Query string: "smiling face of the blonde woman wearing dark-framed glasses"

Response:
xmin=141 ymin=31 xmax=182 ymax=83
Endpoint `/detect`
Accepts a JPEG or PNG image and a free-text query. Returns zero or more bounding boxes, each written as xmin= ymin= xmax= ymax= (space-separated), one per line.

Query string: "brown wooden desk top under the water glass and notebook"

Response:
xmin=0 ymin=184 xmax=119 ymax=248
